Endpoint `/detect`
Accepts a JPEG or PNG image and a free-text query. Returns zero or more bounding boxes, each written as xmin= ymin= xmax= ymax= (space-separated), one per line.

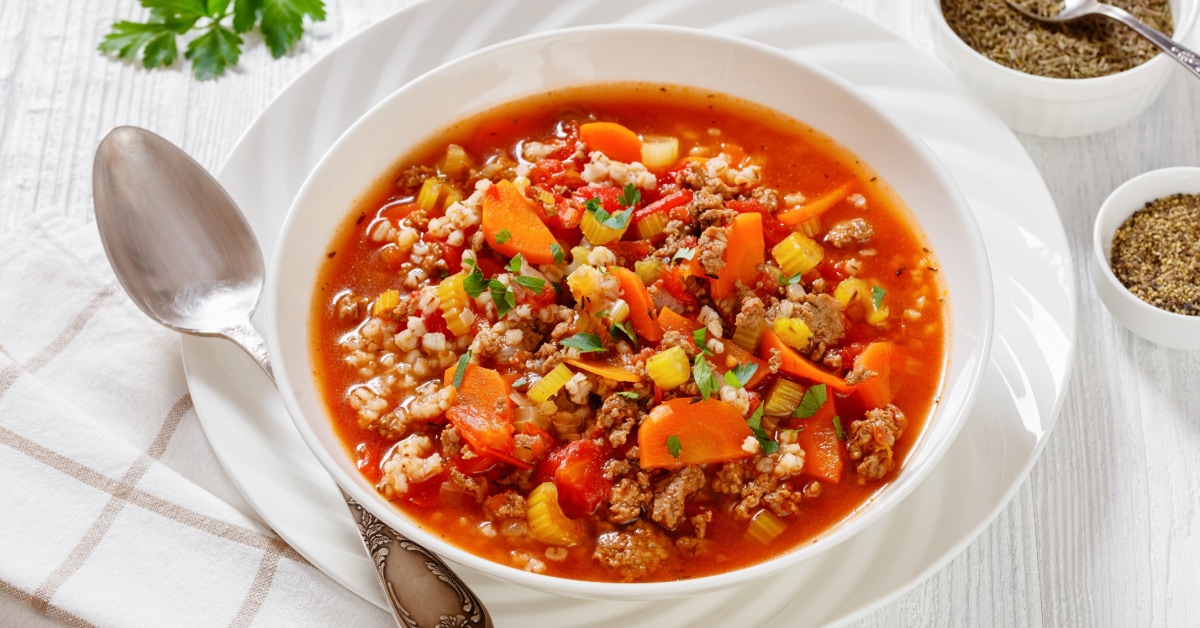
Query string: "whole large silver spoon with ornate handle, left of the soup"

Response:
xmin=92 ymin=126 xmax=492 ymax=627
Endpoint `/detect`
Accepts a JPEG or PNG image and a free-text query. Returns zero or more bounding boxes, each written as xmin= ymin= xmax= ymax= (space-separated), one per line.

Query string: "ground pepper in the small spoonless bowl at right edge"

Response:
xmin=1111 ymin=195 xmax=1200 ymax=316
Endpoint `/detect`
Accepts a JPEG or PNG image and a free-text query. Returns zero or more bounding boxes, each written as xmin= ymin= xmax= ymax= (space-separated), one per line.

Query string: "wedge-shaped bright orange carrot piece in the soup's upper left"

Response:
xmin=480 ymin=179 xmax=558 ymax=264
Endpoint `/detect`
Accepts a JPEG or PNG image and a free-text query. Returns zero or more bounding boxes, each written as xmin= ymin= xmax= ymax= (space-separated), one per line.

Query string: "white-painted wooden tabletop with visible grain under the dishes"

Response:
xmin=0 ymin=0 xmax=1200 ymax=626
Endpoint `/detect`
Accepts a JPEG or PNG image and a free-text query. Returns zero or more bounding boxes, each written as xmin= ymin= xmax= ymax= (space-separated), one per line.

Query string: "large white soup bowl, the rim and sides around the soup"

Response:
xmin=264 ymin=25 xmax=992 ymax=599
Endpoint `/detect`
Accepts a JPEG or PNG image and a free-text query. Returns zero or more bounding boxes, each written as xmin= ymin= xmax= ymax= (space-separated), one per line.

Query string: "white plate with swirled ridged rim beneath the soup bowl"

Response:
xmin=182 ymin=0 xmax=1075 ymax=627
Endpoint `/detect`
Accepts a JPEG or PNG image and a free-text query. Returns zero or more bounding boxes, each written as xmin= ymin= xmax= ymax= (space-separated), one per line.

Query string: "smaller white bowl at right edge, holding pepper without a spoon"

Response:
xmin=1092 ymin=167 xmax=1200 ymax=351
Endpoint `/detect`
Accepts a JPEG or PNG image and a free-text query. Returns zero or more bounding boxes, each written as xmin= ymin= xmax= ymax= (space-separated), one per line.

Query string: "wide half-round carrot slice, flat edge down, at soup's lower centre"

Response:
xmin=637 ymin=397 xmax=754 ymax=468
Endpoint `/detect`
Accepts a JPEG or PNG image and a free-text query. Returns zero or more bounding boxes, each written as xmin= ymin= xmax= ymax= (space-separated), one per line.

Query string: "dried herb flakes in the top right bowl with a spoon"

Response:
xmin=942 ymin=0 xmax=1175 ymax=78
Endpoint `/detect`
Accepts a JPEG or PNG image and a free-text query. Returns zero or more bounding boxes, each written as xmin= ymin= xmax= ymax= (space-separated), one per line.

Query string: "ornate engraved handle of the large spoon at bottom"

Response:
xmin=342 ymin=491 xmax=492 ymax=628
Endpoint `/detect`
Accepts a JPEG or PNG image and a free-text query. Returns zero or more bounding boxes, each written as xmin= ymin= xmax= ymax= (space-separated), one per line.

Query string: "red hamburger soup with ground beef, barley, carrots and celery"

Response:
xmin=310 ymin=85 xmax=949 ymax=581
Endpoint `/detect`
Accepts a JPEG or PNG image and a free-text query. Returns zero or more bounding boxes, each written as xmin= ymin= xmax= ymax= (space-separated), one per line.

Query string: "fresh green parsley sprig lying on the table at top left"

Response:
xmin=98 ymin=0 xmax=325 ymax=80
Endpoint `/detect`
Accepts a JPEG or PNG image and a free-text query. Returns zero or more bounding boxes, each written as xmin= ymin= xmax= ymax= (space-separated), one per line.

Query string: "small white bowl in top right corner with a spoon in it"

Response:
xmin=926 ymin=0 xmax=1200 ymax=137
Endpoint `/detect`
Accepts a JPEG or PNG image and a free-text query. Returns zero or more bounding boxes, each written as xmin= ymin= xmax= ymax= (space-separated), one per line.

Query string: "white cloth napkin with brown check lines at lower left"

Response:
xmin=0 ymin=217 xmax=390 ymax=626
